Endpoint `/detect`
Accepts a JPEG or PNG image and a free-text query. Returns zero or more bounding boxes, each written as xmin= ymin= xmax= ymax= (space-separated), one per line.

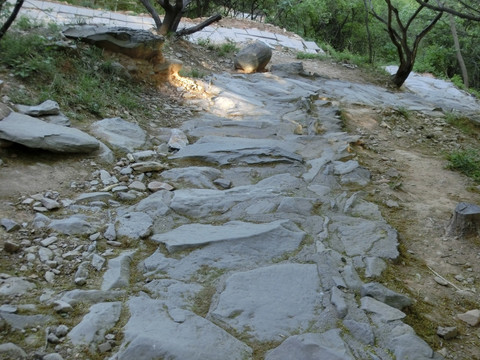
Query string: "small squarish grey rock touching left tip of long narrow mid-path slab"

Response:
xmin=116 ymin=212 xmax=153 ymax=240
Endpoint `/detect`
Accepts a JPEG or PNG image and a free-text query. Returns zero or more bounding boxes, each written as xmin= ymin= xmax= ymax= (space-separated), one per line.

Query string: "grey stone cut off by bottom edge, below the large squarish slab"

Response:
xmin=265 ymin=329 xmax=355 ymax=360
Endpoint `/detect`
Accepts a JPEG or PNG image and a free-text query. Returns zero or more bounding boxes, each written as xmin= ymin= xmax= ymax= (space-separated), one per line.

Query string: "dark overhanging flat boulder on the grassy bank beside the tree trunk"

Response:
xmin=63 ymin=25 xmax=165 ymax=63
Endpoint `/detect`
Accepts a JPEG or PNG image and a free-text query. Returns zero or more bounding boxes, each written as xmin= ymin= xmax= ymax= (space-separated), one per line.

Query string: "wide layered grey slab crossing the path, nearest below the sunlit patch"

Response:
xmin=171 ymin=136 xmax=303 ymax=165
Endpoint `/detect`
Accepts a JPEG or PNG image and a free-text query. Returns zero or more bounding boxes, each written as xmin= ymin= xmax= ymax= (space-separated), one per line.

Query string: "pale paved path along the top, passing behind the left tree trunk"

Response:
xmin=15 ymin=0 xmax=322 ymax=53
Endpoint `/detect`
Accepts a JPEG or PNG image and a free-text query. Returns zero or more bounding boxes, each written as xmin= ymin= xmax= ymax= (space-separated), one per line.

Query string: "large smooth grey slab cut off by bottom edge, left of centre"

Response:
xmin=116 ymin=297 xmax=252 ymax=360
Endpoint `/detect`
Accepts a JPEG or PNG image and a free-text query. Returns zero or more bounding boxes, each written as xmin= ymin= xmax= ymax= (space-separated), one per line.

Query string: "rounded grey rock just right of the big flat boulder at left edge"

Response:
xmin=91 ymin=118 xmax=146 ymax=153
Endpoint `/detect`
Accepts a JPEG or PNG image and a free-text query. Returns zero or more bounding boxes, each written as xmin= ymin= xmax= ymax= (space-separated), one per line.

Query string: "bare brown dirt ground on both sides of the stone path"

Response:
xmin=0 ymin=20 xmax=480 ymax=360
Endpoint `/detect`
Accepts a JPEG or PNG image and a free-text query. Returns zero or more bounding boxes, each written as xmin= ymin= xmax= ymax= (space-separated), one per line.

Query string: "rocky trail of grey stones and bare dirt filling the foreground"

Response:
xmin=0 ymin=5 xmax=480 ymax=360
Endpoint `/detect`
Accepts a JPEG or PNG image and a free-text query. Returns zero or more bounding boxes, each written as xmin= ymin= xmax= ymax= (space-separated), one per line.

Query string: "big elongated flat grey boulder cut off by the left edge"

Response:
xmin=0 ymin=112 xmax=100 ymax=153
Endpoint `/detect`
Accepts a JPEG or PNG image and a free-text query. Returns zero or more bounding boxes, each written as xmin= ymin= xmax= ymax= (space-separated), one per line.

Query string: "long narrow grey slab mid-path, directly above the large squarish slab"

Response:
xmin=152 ymin=220 xmax=296 ymax=252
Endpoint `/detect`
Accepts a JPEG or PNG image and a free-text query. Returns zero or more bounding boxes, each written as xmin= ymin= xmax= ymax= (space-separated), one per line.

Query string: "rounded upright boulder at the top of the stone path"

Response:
xmin=234 ymin=41 xmax=272 ymax=73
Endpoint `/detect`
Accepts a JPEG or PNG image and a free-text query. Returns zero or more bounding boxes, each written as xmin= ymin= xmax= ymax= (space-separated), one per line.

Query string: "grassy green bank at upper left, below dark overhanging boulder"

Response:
xmin=0 ymin=23 xmax=140 ymax=117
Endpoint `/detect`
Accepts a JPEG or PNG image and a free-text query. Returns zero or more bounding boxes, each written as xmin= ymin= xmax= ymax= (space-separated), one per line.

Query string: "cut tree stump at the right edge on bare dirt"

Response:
xmin=447 ymin=202 xmax=480 ymax=237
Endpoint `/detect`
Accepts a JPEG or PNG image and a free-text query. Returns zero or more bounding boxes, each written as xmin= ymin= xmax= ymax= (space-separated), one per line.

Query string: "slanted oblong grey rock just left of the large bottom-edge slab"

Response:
xmin=68 ymin=301 xmax=122 ymax=346
